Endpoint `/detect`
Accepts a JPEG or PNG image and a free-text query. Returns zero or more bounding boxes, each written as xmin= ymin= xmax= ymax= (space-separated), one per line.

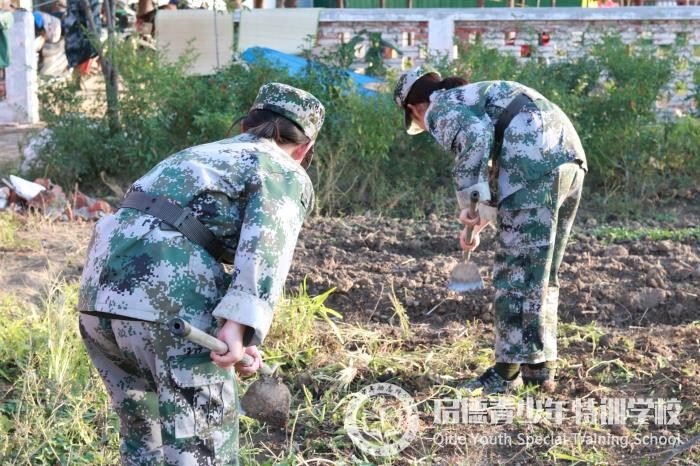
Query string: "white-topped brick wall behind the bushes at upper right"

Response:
xmin=318 ymin=6 xmax=700 ymax=113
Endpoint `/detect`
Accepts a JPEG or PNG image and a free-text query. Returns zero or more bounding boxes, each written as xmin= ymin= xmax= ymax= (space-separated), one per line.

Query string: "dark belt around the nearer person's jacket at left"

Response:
xmin=121 ymin=191 xmax=230 ymax=261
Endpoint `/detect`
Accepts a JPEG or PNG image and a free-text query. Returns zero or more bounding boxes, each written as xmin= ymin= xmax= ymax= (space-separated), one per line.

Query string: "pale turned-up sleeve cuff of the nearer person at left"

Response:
xmin=213 ymin=291 xmax=272 ymax=346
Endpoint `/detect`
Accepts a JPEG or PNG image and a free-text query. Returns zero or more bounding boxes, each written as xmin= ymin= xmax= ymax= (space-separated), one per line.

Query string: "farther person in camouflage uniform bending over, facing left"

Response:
xmin=394 ymin=65 xmax=588 ymax=393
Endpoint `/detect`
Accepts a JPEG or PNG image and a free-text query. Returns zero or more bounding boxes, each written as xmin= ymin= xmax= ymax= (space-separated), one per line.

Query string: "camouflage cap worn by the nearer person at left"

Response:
xmin=250 ymin=83 xmax=326 ymax=141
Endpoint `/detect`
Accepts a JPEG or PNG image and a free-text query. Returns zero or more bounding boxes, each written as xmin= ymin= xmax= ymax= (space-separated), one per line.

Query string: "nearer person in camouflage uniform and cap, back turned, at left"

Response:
xmin=79 ymin=83 xmax=324 ymax=465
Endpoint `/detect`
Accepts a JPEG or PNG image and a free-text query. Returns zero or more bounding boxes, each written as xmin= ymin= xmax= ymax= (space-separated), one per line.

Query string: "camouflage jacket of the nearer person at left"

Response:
xmin=79 ymin=134 xmax=313 ymax=344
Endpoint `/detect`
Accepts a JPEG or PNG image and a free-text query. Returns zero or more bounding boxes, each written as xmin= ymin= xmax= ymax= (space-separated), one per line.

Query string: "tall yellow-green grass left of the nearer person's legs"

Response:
xmin=0 ymin=283 xmax=119 ymax=465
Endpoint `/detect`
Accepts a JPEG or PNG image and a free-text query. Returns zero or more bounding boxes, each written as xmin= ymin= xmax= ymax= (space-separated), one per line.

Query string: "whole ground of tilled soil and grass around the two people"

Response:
xmin=0 ymin=214 xmax=700 ymax=464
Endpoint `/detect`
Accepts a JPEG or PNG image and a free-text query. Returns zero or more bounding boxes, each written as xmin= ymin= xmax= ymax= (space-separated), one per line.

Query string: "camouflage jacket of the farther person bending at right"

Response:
xmin=425 ymin=81 xmax=587 ymax=208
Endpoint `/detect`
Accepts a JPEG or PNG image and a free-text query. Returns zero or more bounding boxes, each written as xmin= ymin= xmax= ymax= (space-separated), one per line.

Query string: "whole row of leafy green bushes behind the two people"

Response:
xmin=34 ymin=37 xmax=700 ymax=216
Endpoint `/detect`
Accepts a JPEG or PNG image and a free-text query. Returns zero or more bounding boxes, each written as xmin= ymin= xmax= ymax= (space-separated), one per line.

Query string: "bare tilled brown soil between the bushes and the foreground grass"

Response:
xmin=292 ymin=217 xmax=700 ymax=327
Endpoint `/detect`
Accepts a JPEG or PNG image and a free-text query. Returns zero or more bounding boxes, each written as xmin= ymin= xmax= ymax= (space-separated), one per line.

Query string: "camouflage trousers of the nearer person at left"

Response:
xmin=80 ymin=314 xmax=238 ymax=466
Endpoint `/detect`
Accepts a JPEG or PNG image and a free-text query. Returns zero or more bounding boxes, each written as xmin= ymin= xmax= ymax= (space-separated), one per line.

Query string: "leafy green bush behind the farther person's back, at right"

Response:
xmin=442 ymin=36 xmax=700 ymax=199
